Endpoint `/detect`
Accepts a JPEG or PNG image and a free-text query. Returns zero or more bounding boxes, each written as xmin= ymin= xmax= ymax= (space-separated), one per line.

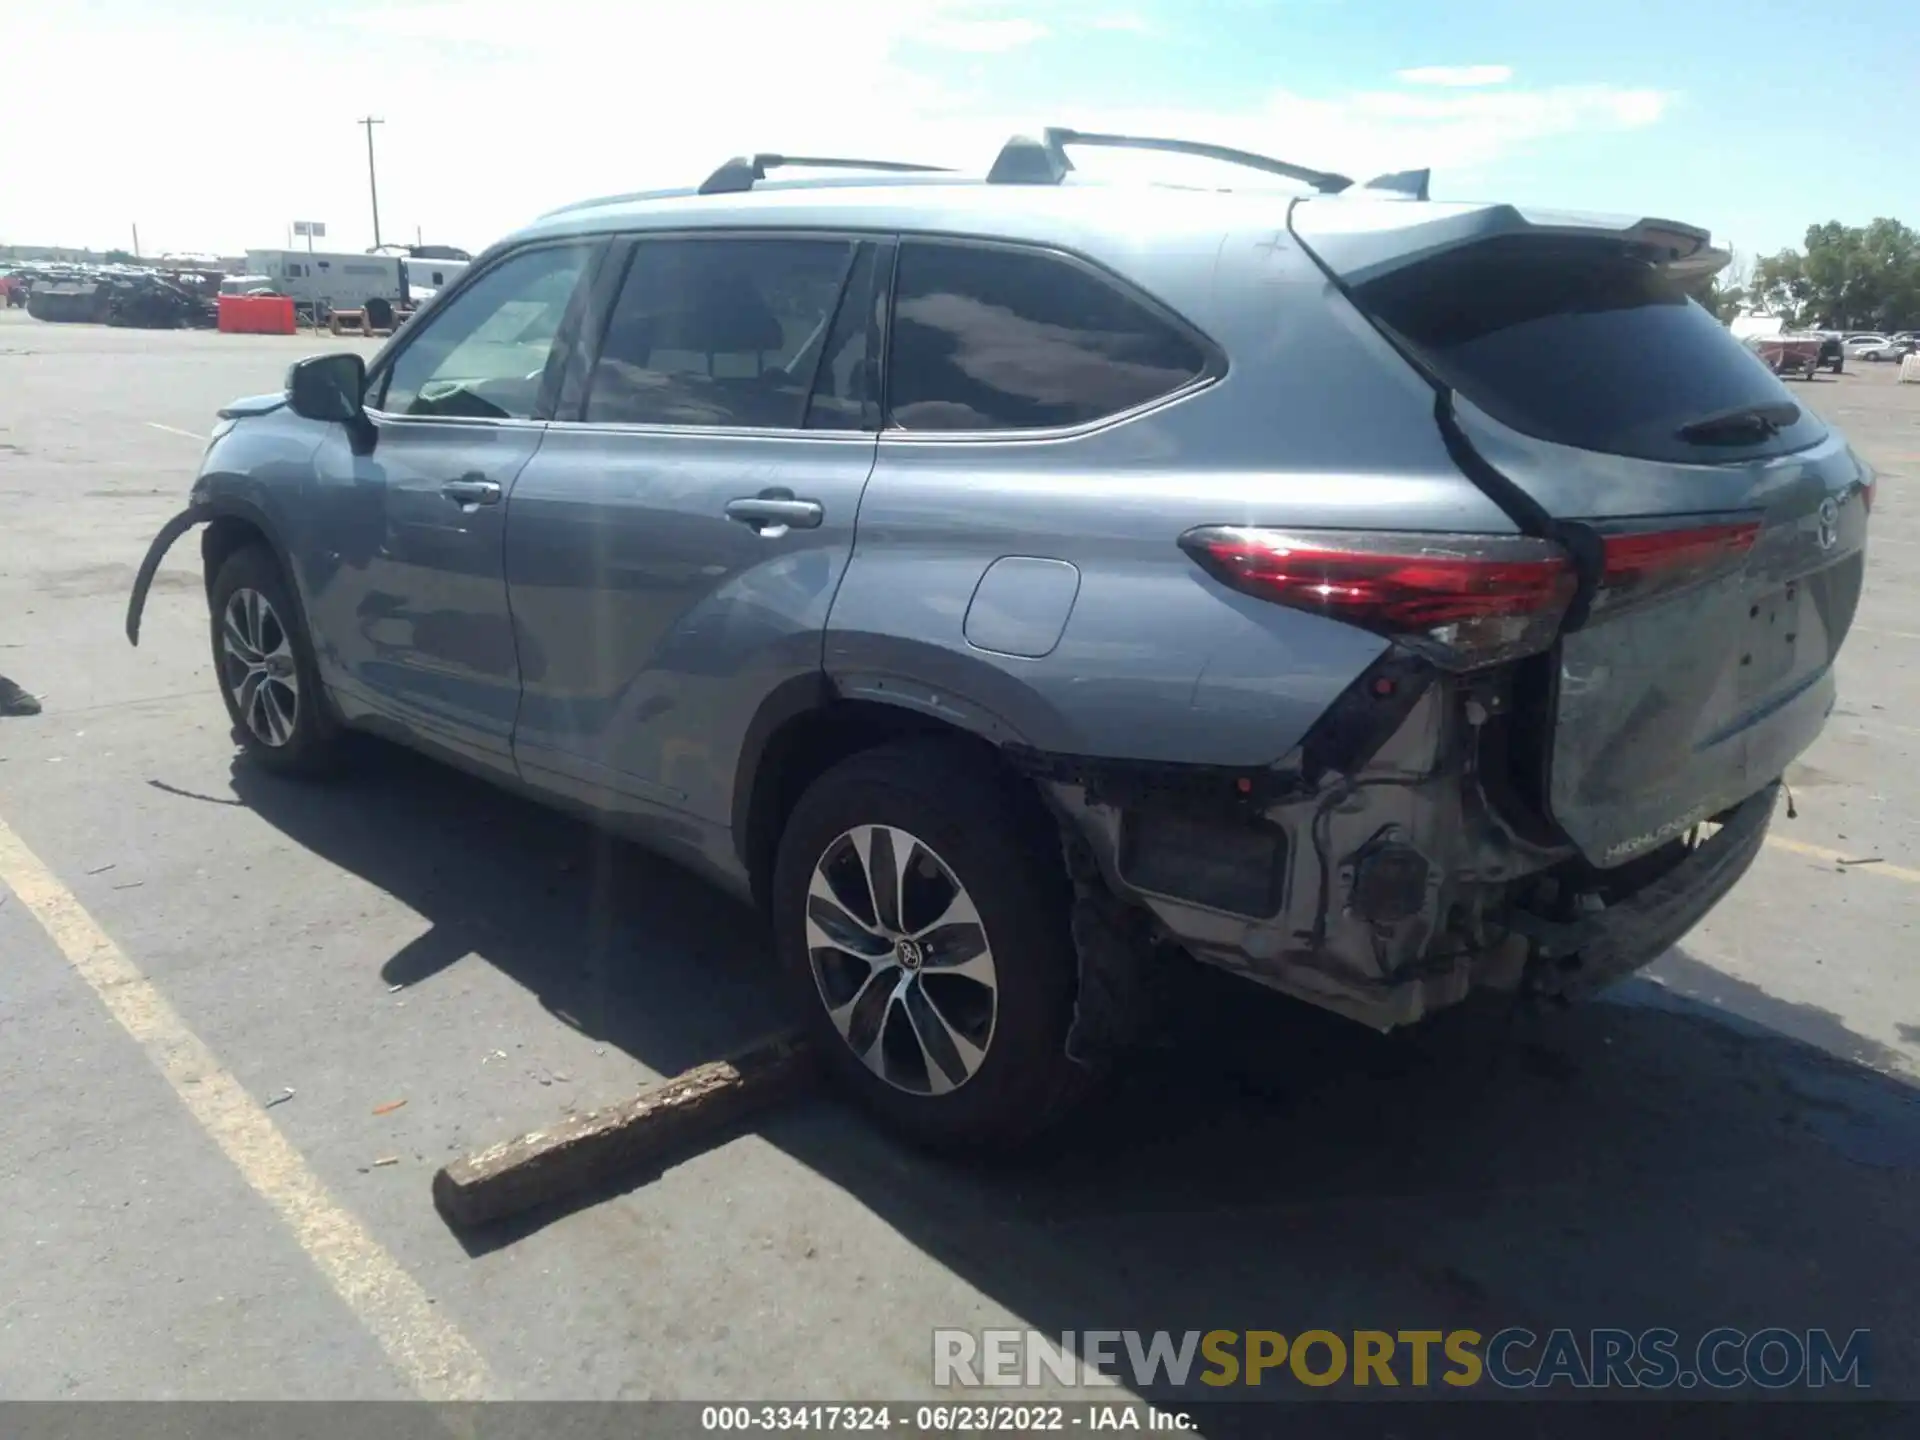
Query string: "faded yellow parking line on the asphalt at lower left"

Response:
xmin=0 ymin=818 xmax=499 ymax=1400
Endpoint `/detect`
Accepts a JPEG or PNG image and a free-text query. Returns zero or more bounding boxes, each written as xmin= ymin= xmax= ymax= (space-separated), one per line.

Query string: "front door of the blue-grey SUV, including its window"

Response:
xmin=317 ymin=244 xmax=591 ymax=768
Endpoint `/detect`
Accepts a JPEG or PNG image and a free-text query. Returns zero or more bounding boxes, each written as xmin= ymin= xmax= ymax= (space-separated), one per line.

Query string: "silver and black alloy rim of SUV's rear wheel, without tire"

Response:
xmin=806 ymin=826 xmax=998 ymax=1094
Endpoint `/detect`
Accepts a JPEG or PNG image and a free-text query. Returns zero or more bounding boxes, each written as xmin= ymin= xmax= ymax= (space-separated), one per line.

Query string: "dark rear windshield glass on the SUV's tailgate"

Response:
xmin=1356 ymin=236 xmax=1826 ymax=463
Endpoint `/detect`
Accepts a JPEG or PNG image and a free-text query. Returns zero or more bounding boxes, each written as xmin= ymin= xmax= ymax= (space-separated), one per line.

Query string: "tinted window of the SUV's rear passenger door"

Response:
xmin=586 ymin=240 xmax=854 ymax=430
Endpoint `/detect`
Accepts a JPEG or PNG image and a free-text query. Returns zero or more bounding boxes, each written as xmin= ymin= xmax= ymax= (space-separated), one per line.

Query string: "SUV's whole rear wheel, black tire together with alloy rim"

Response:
xmin=772 ymin=739 xmax=1091 ymax=1152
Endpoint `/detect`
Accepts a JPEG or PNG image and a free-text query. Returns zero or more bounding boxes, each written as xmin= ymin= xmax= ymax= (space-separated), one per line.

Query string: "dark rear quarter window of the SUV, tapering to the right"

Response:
xmin=887 ymin=242 xmax=1206 ymax=430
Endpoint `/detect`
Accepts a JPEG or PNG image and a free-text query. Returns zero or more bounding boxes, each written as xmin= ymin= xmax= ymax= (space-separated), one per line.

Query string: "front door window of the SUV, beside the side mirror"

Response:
xmin=380 ymin=246 xmax=591 ymax=420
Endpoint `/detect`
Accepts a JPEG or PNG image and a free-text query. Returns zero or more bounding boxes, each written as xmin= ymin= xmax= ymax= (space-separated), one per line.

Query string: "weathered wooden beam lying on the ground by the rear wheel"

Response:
xmin=434 ymin=1033 xmax=814 ymax=1225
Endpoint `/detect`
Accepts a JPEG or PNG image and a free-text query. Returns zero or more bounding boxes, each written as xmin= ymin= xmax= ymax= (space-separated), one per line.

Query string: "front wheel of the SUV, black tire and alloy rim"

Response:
xmin=207 ymin=545 xmax=340 ymax=776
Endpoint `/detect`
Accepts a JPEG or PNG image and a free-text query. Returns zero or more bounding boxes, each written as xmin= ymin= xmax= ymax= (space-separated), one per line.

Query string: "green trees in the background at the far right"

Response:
xmin=1701 ymin=219 xmax=1920 ymax=330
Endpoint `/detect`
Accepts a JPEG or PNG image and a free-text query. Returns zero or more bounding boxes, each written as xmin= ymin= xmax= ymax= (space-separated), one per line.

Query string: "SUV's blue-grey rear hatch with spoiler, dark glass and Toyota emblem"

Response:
xmin=1292 ymin=198 xmax=1872 ymax=866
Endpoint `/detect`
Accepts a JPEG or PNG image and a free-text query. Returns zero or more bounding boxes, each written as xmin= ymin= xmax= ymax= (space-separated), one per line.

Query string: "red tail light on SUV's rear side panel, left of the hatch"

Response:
xmin=1181 ymin=526 xmax=1576 ymax=670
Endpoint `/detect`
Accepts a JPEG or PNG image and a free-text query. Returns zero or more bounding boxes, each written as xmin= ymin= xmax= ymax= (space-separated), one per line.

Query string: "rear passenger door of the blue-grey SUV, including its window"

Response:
xmin=507 ymin=234 xmax=889 ymax=824
